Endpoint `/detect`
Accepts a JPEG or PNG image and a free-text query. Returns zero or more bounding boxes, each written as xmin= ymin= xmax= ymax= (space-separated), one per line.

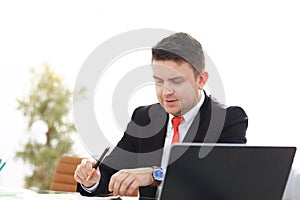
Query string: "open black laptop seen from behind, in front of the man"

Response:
xmin=159 ymin=143 xmax=296 ymax=200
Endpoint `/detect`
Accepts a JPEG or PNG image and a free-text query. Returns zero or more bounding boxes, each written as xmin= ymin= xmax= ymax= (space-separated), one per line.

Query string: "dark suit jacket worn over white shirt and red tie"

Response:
xmin=77 ymin=94 xmax=248 ymax=197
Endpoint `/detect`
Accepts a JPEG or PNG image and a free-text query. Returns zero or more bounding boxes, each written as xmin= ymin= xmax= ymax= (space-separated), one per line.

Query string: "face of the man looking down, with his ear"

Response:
xmin=153 ymin=60 xmax=208 ymax=116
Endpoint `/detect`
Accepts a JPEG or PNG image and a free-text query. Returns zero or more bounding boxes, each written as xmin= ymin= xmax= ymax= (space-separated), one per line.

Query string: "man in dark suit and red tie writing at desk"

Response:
xmin=74 ymin=33 xmax=248 ymax=197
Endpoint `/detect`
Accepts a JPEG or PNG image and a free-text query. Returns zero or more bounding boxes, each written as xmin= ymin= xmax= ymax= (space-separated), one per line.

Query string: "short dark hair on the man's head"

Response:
xmin=152 ymin=32 xmax=205 ymax=74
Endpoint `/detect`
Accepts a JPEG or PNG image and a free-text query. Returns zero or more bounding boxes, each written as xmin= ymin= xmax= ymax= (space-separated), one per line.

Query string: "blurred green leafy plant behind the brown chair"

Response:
xmin=16 ymin=65 xmax=75 ymax=190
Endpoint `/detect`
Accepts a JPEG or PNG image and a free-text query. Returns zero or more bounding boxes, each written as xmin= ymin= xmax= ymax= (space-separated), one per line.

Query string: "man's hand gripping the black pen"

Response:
xmin=74 ymin=158 xmax=101 ymax=188
